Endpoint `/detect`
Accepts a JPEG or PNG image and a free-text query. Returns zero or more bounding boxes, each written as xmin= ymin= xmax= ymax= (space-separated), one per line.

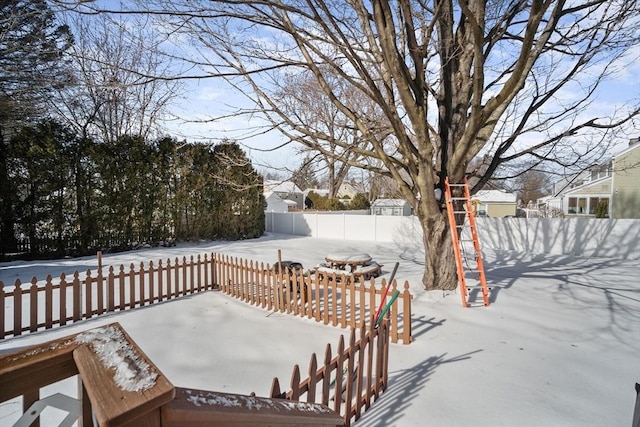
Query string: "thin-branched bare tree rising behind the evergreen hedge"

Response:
xmin=51 ymin=13 xmax=183 ymax=141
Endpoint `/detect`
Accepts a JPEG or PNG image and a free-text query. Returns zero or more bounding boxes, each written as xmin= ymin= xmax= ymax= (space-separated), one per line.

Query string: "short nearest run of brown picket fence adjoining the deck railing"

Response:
xmin=271 ymin=320 xmax=389 ymax=426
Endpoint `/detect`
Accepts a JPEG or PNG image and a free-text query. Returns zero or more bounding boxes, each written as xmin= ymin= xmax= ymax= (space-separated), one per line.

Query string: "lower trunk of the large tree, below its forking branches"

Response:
xmin=420 ymin=212 xmax=458 ymax=290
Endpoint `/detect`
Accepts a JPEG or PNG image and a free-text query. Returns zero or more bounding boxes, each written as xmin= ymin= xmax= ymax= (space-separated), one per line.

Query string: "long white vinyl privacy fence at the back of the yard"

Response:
xmin=266 ymin=212 xmax=640 ymax=260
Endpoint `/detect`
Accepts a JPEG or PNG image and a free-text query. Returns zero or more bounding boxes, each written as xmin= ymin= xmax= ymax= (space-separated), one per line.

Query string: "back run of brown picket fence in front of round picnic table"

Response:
xmin=212 ymin=254 xmax=412 ymax=344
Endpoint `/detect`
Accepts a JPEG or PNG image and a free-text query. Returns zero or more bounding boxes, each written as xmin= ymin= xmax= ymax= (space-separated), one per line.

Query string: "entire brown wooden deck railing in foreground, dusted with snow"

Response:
xmin=0 ymin=323 xmax=344 ymax=427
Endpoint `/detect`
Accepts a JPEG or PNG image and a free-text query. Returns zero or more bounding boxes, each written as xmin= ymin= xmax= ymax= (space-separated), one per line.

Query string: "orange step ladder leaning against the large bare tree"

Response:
xmin=444 ymin=178 xmax=489 ymax=307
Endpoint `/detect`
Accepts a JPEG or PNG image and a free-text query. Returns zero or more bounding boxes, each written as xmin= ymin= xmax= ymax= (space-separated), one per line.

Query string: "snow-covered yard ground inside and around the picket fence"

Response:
xmin=0 ymin=234 xmax=640 ymax=427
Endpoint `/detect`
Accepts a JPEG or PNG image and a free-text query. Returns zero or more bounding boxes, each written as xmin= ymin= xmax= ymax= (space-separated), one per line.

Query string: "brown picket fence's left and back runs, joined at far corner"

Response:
xmin=0 ymin=253 xmax=411 ymax=344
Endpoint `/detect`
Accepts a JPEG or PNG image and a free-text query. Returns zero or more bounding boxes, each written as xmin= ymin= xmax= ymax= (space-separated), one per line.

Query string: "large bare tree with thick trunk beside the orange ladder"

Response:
xmin=57 ymin=0 xmax=640 ymax=289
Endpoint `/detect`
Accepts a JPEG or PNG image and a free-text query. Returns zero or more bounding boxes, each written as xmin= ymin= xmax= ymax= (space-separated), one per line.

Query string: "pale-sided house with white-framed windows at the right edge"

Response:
xmin=539 ymin=138 xmax=640 ymax=219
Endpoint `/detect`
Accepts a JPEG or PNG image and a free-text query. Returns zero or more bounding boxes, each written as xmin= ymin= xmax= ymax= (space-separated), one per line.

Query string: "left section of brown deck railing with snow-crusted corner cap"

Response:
xmin=0 ymin=323 xmax=175 ymax=426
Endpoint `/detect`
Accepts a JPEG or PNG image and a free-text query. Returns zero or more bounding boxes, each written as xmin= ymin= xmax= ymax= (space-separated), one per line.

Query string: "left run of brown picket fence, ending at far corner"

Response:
xmin=0 ymin=254 xmax=214 ymax=339
